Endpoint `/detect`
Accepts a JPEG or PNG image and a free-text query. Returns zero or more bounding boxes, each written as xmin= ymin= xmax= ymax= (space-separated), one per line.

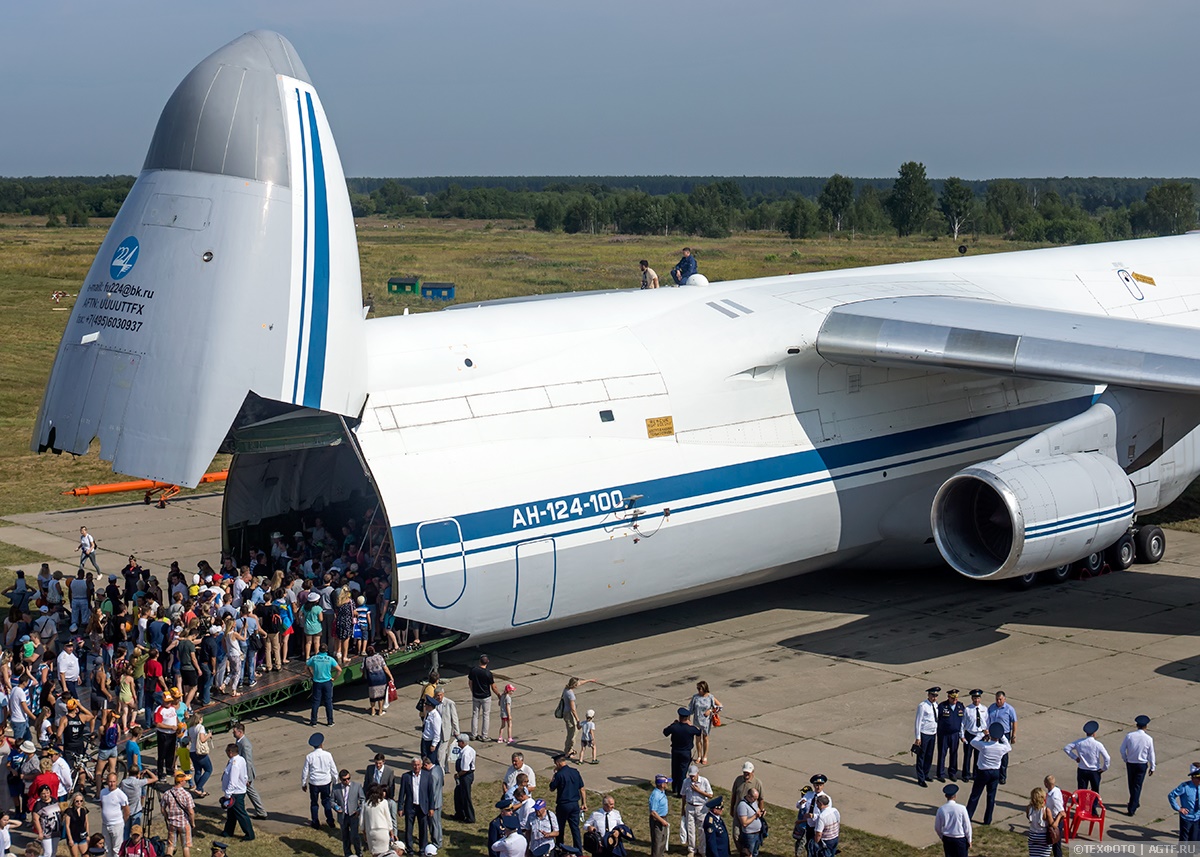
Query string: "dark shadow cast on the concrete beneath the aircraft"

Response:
xmin=443 ymin=565 xmax=1200 ymax=682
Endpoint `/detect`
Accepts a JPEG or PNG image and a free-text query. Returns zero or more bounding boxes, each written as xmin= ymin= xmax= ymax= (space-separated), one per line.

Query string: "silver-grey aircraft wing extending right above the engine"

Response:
xmin=816 ymin=290 xmax=1200 ymax=392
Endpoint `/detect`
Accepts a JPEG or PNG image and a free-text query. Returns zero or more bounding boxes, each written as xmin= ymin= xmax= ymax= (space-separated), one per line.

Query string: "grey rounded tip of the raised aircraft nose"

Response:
xmin=143 ymin=30 xmax=312 ymax=186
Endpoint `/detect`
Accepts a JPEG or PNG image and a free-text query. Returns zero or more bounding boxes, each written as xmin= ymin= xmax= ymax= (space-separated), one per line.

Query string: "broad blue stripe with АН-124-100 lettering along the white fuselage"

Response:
xmin=391 ymin=396 xmax=1093 ymax=568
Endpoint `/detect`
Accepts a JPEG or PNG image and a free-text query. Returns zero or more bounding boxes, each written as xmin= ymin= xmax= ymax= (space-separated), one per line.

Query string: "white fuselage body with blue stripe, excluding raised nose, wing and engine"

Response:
xmin=356 ymin=236 xmax=1200 ymax=640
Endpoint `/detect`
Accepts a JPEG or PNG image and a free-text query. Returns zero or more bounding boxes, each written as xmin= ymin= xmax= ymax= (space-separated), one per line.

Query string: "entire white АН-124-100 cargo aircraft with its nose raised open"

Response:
xmin=32 ymin=31 xmax=1200 ymax=642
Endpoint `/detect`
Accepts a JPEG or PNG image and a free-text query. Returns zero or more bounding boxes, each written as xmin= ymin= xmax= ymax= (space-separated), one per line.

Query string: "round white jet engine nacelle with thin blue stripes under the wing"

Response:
xmin=932 ymin=453 xmax=1134 ymax=580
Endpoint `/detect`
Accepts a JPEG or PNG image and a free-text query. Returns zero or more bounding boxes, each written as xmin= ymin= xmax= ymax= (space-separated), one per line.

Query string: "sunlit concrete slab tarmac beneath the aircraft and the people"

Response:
xmin=0 ymin=496 xmax=1200 ymax=846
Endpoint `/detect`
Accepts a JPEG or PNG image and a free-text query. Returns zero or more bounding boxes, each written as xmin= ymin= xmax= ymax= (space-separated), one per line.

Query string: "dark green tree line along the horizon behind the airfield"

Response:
xmin=0 ymin=171 xmax=1200 ymax=244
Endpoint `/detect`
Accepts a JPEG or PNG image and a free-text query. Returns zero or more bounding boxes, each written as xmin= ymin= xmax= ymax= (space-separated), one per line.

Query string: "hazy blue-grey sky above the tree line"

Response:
xmin=0 ymin=0 xmax=1200 ymax=179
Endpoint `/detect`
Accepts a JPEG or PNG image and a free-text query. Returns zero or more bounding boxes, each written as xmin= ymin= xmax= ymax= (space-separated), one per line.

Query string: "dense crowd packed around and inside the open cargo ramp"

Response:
xmin=0 ymin=514 xmax=441 ymax=857
